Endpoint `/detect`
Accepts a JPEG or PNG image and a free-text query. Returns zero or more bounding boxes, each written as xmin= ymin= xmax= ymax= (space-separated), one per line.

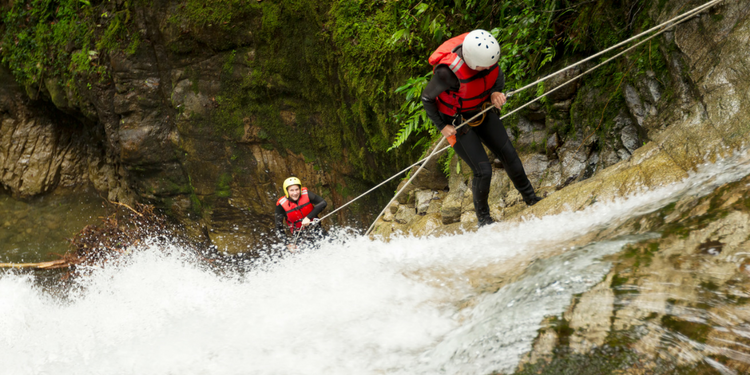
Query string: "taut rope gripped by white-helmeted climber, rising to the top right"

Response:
xmin=365 ymin=0 xmax=724 ymax=236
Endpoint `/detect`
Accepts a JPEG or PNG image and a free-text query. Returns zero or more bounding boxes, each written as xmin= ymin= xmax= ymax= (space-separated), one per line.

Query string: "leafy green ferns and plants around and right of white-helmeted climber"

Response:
xmin=390 ymin=0 xmax=668 ymax=174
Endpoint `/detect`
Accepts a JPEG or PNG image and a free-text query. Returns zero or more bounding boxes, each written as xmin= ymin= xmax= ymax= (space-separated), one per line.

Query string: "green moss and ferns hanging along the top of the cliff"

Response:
xmin=0 ymin=0 xmax=680 ymax=217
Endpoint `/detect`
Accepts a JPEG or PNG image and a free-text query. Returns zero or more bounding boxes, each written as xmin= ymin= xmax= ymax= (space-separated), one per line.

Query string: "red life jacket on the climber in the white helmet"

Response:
xmin=428 ymin=33 xmax=500 ymax=116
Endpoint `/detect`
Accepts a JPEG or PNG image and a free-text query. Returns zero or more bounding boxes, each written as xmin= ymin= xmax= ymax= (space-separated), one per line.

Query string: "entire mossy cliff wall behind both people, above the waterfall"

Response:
xmin=0 ymin=0 xmax=746 ymax=251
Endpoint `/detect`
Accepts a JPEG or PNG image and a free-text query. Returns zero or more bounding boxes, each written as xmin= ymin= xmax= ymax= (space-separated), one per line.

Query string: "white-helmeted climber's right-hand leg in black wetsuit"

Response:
xmin=474 ymin=112 xmax=541 ymax=206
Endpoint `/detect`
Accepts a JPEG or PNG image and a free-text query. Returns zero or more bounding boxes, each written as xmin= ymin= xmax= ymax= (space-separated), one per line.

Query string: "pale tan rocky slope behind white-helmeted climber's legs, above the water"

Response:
xmin=373 ymin=1 xmax=750 ymax=238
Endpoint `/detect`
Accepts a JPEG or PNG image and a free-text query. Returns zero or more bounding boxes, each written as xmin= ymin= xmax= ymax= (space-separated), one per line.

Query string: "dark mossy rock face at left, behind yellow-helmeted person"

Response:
xmin=0 ymin=1 xmax=414 ymax=251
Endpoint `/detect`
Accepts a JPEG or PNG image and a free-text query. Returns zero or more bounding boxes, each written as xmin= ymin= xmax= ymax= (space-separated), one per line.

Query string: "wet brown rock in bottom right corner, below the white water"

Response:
xmin=517 ymin=171 xmax=750 ymax=374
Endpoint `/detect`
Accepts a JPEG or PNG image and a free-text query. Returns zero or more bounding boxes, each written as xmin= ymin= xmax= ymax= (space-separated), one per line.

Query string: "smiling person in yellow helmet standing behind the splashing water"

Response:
xmin=275 ymin=177 xmax=328 ymax=249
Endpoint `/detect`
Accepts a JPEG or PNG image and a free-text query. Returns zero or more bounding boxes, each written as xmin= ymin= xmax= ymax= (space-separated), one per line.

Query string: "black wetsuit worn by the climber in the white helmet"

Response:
xmin=422 ymin=50 xmax=539 ymax=224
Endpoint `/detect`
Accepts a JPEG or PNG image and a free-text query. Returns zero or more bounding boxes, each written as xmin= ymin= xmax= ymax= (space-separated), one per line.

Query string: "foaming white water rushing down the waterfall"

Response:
xmin=0 ymin=151 xmax=750 ymax=375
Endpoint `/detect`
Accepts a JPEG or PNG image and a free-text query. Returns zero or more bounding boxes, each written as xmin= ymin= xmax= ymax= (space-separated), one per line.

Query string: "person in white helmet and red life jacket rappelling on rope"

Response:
xmin=421 ymin=29 xmax=541 ymax=226
